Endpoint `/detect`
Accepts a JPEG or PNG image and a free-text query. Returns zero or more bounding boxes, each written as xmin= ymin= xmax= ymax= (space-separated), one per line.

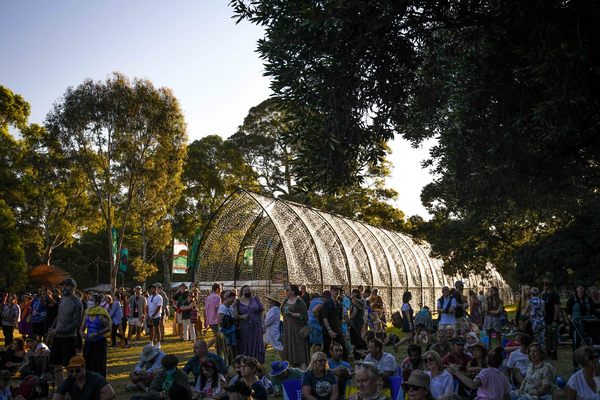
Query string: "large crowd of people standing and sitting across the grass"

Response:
xmin=0 ymin=279 xmax=600 ymax=400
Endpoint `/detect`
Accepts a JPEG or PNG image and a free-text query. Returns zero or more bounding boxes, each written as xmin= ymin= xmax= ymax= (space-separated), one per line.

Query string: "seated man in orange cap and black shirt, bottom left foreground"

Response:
xmin=52 ymin=356 xmax=115 ymax=400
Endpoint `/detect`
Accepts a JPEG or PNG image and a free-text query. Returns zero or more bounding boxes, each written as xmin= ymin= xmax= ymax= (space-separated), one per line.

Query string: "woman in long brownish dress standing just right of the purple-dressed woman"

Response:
xmin=281 ymin=285 xmax=309 ymax=369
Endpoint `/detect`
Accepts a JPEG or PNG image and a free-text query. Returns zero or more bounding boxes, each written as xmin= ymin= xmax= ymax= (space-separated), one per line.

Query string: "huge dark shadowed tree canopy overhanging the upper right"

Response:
xmin=232 ymin=0 xmax=600 ymax=278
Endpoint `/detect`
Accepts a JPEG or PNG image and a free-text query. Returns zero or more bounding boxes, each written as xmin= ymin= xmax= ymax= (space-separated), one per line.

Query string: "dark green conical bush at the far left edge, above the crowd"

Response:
xmin=0 ymin=200 xmax=27 ymax=292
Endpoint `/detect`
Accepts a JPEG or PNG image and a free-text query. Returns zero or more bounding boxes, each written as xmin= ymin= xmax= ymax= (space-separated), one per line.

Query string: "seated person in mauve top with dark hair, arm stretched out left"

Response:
xmin=448 ymin=347 xmax=510 ymax=400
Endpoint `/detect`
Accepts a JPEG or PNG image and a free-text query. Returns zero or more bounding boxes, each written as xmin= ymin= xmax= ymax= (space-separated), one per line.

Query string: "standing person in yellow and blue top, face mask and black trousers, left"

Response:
xmin=79 ymin=294 xmax=112 ymax=378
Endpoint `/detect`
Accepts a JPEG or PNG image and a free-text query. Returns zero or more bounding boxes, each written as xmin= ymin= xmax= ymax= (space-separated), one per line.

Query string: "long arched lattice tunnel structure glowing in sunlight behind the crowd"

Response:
xmin=196 ymin=190 xmax=511 ymax=310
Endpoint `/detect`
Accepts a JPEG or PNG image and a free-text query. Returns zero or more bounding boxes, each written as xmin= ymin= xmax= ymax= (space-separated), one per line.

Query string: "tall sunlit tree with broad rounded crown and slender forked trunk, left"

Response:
xmin=46 ymin=73 xmax=187 ymax=288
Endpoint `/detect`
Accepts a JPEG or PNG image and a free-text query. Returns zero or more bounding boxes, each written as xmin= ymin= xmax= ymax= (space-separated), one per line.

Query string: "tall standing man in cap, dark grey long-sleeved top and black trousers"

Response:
xmin=48 ymin=278 xmax=83 ymax=386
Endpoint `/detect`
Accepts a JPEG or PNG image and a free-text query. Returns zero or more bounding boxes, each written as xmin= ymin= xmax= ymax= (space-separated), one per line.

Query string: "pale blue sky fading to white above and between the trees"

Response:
xmin=0 ymin=0 xmax=431 ymax=218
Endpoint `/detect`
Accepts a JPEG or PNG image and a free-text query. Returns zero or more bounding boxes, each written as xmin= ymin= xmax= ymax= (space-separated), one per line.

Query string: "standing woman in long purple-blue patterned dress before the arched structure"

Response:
xmin=237 ymin=285 xmax=265 ymax=364
